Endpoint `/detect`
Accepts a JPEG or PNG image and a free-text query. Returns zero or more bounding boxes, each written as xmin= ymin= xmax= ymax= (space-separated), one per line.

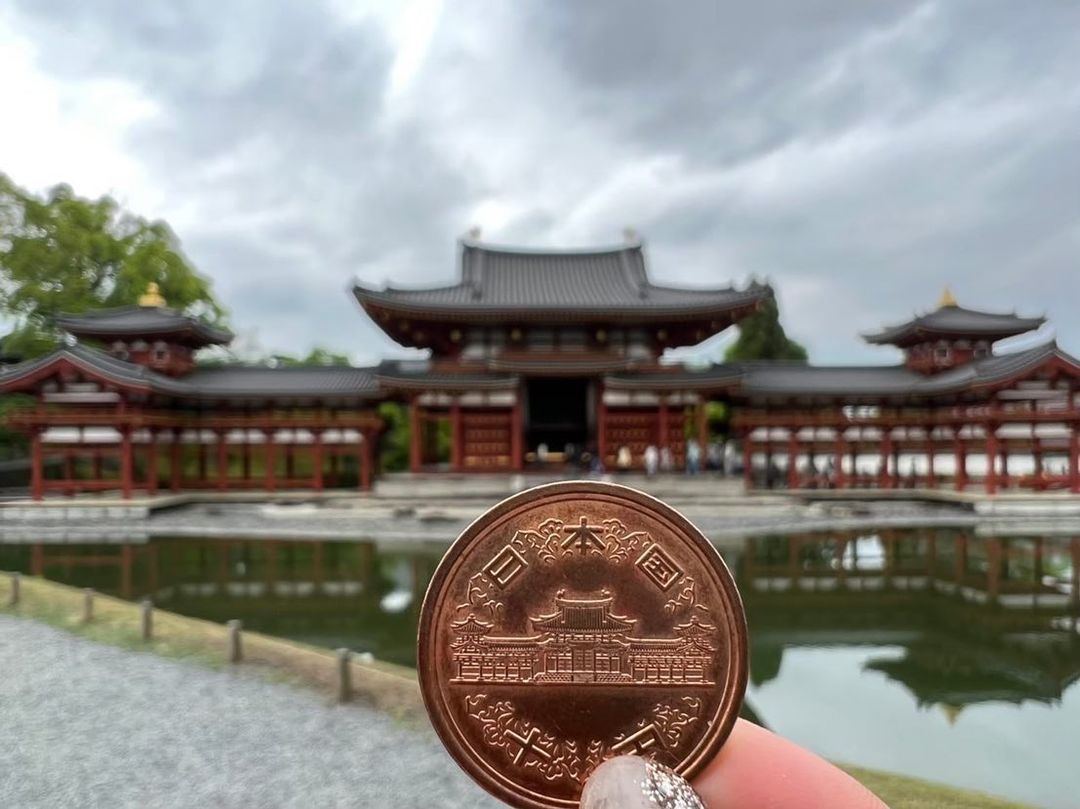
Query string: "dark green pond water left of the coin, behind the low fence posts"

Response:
xmin=0 ymin=538 xmax=445 ymax=665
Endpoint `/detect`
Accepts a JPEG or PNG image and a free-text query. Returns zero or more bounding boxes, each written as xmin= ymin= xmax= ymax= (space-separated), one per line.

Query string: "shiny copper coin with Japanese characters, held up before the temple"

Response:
xmin=417 ymin=482 xmax=746 ymax=809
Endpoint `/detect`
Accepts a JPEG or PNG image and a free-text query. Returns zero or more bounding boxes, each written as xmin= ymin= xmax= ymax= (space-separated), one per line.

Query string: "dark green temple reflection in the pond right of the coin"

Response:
xmin=737 ymin=528 xmax=1080 ymax=713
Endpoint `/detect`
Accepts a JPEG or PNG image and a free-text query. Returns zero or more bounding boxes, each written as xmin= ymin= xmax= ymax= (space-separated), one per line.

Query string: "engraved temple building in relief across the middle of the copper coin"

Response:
xmin=450 ymin=591 xmax=716 ymax=685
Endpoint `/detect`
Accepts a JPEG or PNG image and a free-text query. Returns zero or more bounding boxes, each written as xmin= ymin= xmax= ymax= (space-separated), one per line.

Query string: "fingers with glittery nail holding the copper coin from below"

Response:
xmin=581 ymin=719 xmax=888 ymax=809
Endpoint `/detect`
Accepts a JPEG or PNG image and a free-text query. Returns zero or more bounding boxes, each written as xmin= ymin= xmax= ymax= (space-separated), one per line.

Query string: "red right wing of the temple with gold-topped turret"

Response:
xmin=730 ymin=289 xmax=1080 ymax=494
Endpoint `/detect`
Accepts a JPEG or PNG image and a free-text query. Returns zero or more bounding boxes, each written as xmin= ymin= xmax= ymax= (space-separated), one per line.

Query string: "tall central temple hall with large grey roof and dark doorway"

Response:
xmin=353 ymin=240 xmax=771 ymax=472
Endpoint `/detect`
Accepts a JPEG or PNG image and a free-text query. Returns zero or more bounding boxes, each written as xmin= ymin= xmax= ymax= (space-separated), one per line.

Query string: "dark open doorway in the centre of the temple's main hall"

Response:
xmin=525 ymin=377 xmax=592 ymax=462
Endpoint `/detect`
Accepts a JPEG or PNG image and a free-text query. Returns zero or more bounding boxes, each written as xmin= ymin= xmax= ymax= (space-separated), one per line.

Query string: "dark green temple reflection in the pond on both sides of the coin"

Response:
xmin=0 ymin=528 xmax=1080 ymax=695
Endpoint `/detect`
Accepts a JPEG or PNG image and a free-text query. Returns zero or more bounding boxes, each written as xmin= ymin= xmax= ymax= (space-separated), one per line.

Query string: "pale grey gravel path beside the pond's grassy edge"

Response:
xmin=0 ymin=616 xmax=499 ymax=809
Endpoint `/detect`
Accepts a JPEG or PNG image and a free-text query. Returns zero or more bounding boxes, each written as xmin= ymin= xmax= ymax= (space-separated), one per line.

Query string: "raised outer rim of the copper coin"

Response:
xmin=417 ymin=481 xmax=750 ymax=809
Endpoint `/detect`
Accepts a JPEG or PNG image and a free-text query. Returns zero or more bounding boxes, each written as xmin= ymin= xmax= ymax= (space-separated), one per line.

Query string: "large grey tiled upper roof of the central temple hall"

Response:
xmin=353 ymin=242 xmax=771 ymax=316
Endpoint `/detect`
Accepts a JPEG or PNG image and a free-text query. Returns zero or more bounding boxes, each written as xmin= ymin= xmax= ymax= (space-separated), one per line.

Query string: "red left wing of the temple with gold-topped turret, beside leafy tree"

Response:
xmin=0 ymin=284 xmax=381 ymax=500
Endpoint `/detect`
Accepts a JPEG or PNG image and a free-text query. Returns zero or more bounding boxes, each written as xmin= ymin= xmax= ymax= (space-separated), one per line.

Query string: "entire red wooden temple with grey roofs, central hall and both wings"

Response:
xmin=0 ymin=240 xmax=1080 ymax=499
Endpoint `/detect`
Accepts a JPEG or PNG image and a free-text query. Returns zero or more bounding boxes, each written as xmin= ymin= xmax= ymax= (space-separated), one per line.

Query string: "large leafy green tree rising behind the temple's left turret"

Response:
xmin=0 ymin=174 xmax=225 ymax=358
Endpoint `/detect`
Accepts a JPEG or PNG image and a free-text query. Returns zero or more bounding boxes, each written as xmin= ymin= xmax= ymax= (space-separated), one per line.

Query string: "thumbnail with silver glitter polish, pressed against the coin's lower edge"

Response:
xmin=581 ymin=756 xmax=705 ymax=809
